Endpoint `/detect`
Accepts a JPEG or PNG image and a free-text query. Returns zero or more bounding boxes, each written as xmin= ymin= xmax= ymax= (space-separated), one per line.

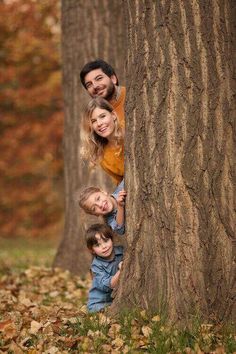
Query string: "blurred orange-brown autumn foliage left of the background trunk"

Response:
xmin=0 ymin=0 xmax=63 ymax=237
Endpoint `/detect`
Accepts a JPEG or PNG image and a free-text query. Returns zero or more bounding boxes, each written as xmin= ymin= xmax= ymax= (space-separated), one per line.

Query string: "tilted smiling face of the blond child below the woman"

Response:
xmin=86 ymin=191 xmax=115 ymax=216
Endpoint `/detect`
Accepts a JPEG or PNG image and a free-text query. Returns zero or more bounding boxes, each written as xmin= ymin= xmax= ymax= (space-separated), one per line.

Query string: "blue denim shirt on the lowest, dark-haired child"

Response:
xmin=87 ymin=246 xmax=123 ymax=312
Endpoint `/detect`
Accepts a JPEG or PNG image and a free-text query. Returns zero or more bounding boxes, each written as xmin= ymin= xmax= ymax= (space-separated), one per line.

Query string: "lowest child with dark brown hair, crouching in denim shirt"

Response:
xmin=86 ymin=224 xmax=123 ymax=312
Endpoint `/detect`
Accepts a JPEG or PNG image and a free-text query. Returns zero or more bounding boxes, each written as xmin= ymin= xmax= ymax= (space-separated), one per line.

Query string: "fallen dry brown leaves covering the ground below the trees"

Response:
xmin=0 ymin=267 xmax=236 ymax=354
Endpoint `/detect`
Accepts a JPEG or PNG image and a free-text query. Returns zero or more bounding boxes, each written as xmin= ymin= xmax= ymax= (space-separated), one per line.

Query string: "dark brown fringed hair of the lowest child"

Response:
xmin=85 ymin=224 xmax=113 ymax=250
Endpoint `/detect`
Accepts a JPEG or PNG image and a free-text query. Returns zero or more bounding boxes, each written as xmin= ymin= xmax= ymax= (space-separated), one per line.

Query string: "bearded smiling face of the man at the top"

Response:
xmin=85 ymin=69 xmax=117 ymax=101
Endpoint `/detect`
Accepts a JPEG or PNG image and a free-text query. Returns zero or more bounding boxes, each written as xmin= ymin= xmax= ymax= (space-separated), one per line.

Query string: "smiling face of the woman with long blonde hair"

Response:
xmin=91 ymin=107 xmax=116 ymax=140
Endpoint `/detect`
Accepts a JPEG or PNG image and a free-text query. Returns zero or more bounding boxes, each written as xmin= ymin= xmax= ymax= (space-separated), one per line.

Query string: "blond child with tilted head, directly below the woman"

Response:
xmin=76 ymin=180 xmax=126 ymax=235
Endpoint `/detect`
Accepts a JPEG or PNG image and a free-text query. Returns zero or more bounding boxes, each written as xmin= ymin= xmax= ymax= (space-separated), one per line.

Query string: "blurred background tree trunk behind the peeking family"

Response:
xmin=54 ymin=0 xmax=125 ymax=274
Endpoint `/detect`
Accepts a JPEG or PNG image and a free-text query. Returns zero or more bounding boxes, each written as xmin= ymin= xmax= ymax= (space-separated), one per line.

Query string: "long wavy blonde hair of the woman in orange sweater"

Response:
xmin=80 ymin=97 xmax=124 ymax=165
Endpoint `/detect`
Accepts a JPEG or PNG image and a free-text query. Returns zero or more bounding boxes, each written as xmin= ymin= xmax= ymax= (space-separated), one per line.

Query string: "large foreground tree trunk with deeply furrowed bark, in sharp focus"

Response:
xmin=113 ymin=0 xmax=236 ymax=319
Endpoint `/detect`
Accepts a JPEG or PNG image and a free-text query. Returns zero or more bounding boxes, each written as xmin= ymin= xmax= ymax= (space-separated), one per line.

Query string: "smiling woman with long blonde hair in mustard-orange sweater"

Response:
xmin=81 ymin=97 xmax=124 ymax=185
